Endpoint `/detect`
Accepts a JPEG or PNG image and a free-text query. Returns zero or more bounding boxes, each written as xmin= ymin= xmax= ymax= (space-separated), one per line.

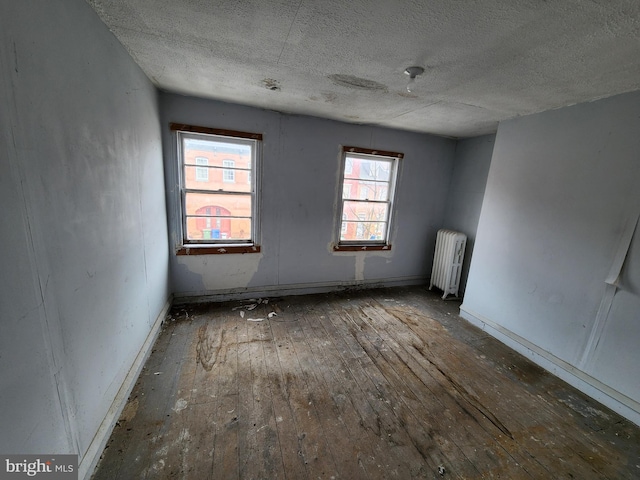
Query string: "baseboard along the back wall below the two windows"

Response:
xmin=173 ymin=276 xmax=429 ymax=305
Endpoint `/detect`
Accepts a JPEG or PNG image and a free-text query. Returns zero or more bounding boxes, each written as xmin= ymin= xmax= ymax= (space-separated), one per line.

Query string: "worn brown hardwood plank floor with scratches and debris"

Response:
xmin=93 ymin=287 xmax=640 ymax=480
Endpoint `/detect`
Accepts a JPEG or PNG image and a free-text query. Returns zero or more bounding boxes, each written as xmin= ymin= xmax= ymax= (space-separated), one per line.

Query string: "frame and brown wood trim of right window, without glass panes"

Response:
xmin=334 ymin=147 xmax=404 ymax=250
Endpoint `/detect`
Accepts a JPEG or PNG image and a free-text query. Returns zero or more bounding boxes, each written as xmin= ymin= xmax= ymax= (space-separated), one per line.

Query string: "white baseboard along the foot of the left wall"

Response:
xmin=78 ymin=297 xmax=173 ymax=480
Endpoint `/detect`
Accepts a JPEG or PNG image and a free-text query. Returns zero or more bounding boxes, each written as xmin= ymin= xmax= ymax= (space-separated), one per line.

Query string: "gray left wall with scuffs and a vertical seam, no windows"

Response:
xmin=0 ymin=0 xmax=169 ymax=472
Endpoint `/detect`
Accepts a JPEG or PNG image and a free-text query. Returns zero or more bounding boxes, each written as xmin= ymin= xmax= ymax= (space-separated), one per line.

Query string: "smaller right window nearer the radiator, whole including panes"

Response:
xmin=335 ymin=147 xmax=403 ymax=250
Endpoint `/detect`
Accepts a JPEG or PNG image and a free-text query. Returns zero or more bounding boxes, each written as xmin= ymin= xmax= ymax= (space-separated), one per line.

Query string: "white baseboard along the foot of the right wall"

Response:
xmin=460 ymin=303 xmax=640 ymax=426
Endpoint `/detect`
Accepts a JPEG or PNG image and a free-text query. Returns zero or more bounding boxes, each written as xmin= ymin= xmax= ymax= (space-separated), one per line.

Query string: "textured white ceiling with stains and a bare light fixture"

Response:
xmin=87 ymin=0 xmax=640 ymax=137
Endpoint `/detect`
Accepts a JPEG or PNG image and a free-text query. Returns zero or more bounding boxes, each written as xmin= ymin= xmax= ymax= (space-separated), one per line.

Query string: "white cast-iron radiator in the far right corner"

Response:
xmin=429 ymin=229 xmax=467 ymax=299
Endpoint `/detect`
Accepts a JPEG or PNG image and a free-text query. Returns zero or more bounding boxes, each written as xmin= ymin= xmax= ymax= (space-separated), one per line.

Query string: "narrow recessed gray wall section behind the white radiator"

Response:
xmin=443 ymin=135 xmax=496 ymax=293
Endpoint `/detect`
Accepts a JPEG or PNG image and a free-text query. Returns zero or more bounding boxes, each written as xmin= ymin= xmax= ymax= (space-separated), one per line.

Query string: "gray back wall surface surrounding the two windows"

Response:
xmin=161 ymin=94 xmax=455 ymax=296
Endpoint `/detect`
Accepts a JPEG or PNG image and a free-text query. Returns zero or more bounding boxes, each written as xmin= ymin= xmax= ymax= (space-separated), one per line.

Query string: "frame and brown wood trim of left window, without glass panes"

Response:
xmin=170 ymin=124 xmax=262 ymax=249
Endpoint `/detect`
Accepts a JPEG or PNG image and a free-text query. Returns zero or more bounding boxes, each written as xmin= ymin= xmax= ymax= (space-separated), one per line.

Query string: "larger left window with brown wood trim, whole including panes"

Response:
xmin=171 ymin=124 xmax=262 ymax=255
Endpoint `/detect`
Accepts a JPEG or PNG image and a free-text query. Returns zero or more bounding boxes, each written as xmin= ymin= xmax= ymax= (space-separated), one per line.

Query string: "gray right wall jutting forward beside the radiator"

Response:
xmin=462 ymin=92 xmax=640 ymax=422
